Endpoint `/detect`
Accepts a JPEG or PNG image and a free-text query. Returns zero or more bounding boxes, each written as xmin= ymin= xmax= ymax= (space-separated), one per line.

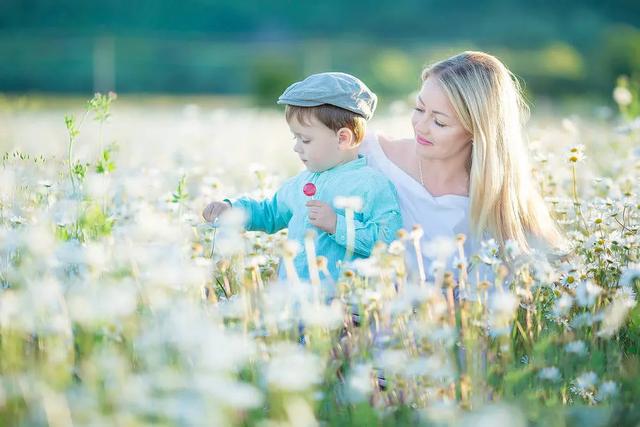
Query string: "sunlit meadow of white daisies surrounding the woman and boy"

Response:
xmin=0 ymin=81 xmax=640 ymax=426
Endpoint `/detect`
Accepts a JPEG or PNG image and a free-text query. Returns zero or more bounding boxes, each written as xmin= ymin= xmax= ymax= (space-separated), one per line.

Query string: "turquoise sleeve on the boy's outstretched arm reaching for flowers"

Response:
xmin=230 ymin=183 xmax=292 ymax=234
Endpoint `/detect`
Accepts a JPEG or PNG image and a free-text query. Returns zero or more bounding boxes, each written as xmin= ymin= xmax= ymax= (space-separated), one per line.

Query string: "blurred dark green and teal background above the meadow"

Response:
xmin=0 ymin=0 xmax=640 ymax=105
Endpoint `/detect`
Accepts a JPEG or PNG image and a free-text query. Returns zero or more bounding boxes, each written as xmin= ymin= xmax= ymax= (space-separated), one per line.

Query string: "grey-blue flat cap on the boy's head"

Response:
xmin=278 ymin=73 xmax=378 ymax=120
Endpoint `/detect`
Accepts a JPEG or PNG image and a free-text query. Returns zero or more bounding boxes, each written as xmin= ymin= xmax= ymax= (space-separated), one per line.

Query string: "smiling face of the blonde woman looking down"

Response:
xmin=411 ymin=77 xmax=471 ymax=160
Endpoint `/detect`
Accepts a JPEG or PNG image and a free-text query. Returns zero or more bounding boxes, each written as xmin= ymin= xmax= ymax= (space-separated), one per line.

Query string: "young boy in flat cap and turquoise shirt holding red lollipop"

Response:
xmin=202 ymin=73 xmax=402 ymax=280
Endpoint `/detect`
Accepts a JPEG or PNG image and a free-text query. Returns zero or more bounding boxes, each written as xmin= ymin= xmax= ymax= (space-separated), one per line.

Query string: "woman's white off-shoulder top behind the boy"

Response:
xmin=360 ymin=133 xmax=479 ymax=276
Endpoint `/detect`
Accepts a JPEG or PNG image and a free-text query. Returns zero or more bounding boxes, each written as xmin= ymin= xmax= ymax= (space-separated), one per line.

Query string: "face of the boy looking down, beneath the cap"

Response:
xmin=289 ymin=117 xmax=344 ymax=172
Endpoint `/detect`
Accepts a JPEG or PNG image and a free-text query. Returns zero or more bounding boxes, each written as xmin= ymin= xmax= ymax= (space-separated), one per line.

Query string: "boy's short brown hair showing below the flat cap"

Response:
xmin=285 ymin=104 xmax=367 ymax=144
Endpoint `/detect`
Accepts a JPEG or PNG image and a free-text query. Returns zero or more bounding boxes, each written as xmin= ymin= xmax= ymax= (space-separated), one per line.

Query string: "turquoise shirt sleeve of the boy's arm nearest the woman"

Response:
xmin=331 ymin=181 xmax=402 ymax=257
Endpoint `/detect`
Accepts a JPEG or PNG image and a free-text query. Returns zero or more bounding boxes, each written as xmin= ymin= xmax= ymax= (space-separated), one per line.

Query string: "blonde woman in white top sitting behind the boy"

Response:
xmin=362 ymin=52 xmax=564 ymax=280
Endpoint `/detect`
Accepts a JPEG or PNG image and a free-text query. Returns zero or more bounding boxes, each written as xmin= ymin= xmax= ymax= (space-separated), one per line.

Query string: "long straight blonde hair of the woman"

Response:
xmin=422 ymin=52 xmax=566 ymax=252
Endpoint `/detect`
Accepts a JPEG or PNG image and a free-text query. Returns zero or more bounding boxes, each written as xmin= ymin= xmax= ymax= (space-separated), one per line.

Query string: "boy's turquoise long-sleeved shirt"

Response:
xmin=232 ymin=155 xmax=402 ymax=280
